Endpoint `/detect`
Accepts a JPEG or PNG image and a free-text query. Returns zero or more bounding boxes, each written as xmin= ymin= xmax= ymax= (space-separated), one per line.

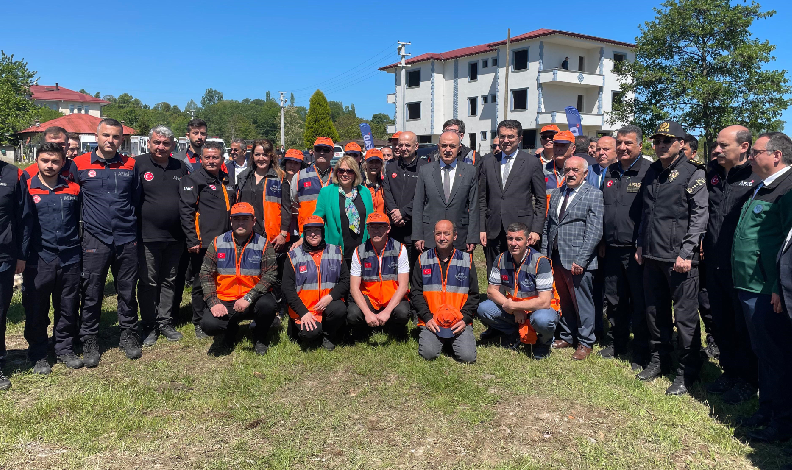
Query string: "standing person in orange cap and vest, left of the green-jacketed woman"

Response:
xmin=291 ymin=137 xmax=334 ymax=239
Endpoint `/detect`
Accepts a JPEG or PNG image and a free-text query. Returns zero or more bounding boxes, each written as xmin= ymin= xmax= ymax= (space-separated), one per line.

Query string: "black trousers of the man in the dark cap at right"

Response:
xmin=643 ymin=258 xmax=701 ymax=378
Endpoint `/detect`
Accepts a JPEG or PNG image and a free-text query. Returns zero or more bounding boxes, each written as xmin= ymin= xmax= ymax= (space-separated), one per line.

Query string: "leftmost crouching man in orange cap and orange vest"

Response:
xmin=200 ymin=202 xmax=278 ymax=355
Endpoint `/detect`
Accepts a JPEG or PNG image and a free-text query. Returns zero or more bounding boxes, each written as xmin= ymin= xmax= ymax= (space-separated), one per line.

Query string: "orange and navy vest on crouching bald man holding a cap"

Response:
xmin=418 ymin=249 xmax=473 ymax=326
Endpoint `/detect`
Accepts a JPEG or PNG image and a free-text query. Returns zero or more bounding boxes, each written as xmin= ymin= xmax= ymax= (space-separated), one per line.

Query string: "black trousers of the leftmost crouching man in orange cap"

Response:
xmin=201 ymin=292 xmax=278 ymax=342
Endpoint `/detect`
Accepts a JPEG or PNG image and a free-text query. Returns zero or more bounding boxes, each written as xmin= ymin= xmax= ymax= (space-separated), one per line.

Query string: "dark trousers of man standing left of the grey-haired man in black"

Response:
xmin=80 ymin=231 xmax=138 ymax=338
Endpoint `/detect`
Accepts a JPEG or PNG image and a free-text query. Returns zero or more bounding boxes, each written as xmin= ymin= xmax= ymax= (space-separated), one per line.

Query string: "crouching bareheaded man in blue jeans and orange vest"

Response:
xmin=477 ymin=222 xmax=558 ymax=360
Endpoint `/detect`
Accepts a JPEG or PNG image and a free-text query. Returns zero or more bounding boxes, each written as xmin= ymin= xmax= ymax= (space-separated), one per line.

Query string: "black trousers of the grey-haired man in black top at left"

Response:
xmin=138 ymin=241 xmax=184 ymax=329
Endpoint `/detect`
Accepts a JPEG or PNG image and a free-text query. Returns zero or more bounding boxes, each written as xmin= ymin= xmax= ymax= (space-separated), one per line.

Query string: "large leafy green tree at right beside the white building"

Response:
xmin=609 ymin=0 xmax=790 ymax=154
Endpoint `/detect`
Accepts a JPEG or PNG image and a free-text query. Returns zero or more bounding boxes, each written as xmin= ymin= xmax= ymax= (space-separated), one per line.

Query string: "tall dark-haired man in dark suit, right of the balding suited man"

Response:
xmin=479 ymin=120 xmax=547 ymax=272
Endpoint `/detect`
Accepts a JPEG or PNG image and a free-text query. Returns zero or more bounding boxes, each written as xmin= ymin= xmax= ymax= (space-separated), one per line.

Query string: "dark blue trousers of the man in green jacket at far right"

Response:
xmin=737 ymin=290 xmax=792 ymax=430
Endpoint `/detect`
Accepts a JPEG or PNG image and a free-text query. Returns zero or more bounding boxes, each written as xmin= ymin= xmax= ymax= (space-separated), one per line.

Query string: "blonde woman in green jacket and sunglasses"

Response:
xmin=314 ymin=155 xmax=374 ymax=267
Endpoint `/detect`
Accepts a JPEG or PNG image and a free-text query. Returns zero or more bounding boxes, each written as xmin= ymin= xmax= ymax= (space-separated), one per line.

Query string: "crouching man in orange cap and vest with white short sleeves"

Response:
xmin=347 ymin=211 xmax=411 ymax=340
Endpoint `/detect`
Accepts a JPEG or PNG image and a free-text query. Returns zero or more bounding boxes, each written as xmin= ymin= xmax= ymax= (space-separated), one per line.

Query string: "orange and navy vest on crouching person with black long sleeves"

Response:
xmin=289 ymin=244 xmax=344 ymax=325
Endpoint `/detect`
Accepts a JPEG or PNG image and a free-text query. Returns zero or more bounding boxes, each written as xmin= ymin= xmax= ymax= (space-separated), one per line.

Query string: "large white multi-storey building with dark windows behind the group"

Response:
xmin=381 ymin=29 xmax=635 ymax=153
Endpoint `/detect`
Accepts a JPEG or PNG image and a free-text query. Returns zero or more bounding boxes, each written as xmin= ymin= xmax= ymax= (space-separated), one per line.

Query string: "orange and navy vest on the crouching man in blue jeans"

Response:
xmin=498 ymin=247 xmax=561 ymax=344
